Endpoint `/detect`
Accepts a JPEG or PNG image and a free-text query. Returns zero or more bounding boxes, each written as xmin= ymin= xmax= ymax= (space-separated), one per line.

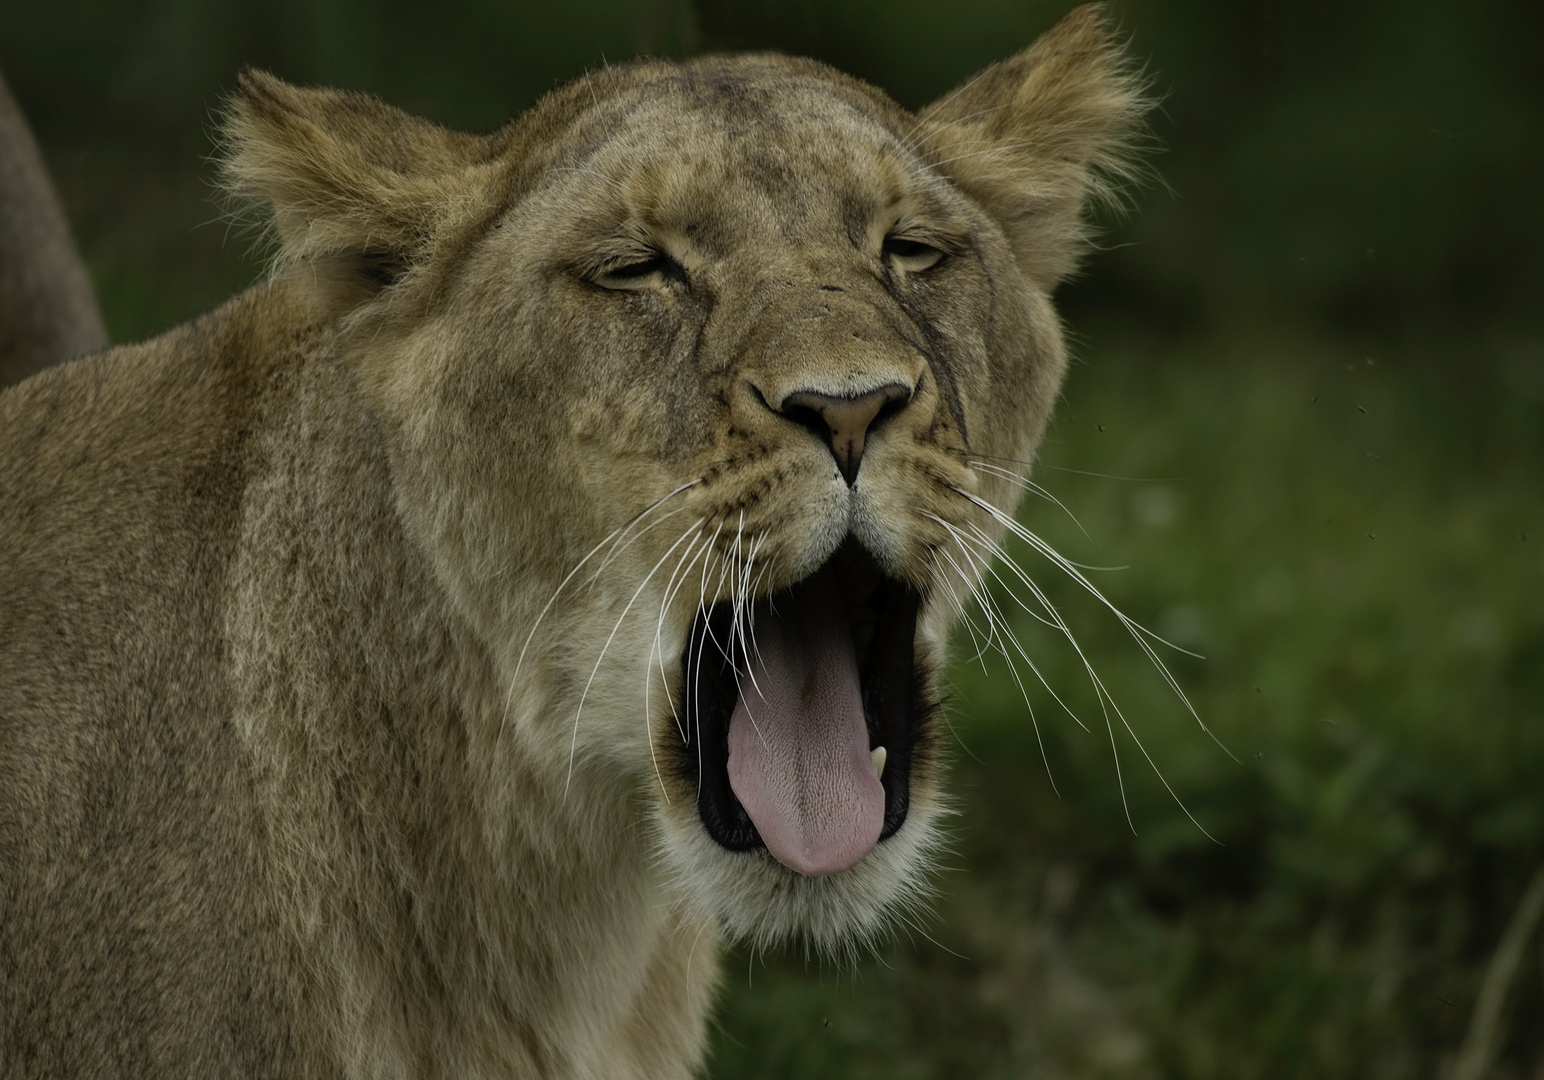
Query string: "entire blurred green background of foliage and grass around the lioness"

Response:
xmin=0 ymin=0 xmax=1544 ymax=1078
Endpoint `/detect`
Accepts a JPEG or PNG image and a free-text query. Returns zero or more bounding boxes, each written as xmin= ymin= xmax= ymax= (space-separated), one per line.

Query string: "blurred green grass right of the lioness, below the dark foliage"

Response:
xmin=713 ymin=331 xmax=1544 ymax=1078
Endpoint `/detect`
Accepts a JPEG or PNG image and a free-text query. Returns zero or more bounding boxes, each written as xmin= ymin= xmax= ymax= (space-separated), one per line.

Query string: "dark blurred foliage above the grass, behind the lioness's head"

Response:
xmin=0 ymin=0 xmax=1544 ymax=346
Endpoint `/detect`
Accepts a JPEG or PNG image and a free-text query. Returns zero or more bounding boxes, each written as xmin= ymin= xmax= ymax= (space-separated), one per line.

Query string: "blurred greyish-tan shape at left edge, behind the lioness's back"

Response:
xmin=0 ymin=68 xmax=107 ymax=386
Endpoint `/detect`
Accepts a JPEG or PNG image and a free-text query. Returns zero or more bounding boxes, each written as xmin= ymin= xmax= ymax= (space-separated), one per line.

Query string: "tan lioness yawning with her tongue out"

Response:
xmin=0 ymin=8 xmax=1143 ymax=1077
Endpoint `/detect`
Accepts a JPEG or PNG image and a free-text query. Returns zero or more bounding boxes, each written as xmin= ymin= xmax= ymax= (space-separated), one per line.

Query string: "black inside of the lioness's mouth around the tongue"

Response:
xmin=675 ymin=538 xmax=922 ymax=851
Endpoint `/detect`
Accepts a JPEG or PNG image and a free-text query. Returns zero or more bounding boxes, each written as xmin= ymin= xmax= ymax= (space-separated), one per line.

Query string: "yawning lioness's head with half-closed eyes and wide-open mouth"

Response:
xmin=228 ymin=8 xmax=1135 ymax=946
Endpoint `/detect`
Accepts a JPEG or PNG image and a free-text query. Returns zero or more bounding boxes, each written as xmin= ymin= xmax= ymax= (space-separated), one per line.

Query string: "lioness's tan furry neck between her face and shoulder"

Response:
xmin=227 ymin=346 xmax=715 ymax=1075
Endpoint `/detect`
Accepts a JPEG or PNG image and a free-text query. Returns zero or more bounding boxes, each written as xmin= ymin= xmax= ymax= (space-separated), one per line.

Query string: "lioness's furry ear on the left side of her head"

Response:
xmin=224 ymin=68 xmax=488 ymax=306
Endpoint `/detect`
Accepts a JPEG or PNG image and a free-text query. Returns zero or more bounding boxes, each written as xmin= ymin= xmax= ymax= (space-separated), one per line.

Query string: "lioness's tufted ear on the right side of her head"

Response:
xmin=917 ymin=3 xmax=1150 ymax=290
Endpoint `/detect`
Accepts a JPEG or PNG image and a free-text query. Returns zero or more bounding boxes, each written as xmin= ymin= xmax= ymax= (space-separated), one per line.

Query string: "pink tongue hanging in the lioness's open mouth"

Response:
xmin=729 ymin=572 xmax=885 ymax=876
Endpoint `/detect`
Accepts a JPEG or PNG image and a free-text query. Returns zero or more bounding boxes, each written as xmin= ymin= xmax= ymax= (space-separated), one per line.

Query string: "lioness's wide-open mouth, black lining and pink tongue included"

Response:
xmin=678 ymin=538 xmax=923 ymax=876
